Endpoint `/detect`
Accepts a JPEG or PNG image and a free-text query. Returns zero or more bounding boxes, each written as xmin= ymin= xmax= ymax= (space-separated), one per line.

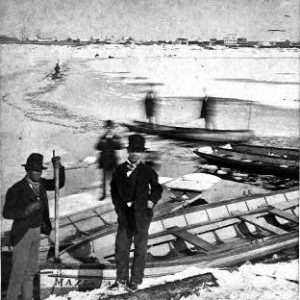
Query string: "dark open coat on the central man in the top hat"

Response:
xmin=111 ymin=162 xmax=162 ymax=228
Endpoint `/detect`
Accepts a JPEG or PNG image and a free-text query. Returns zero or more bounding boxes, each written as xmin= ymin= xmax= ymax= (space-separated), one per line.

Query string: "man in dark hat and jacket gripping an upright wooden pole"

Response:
xmin=3 ymin=153 xmax=65 ymax=300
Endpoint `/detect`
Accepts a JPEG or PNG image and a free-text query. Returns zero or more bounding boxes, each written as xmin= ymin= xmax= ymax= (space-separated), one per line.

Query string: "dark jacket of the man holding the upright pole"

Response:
xmin=3 ymin=167 xmax=65 ymax=246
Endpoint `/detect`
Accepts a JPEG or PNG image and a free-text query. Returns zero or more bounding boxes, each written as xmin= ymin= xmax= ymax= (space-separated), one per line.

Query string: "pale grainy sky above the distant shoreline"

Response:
xmin=0 ymin=0 xmax=299 ymax=41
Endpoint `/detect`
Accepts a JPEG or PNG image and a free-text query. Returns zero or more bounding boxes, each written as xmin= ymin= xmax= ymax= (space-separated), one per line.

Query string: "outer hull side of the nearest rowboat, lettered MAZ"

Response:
xmin=40 ymin=233 xmax=299 ymax=299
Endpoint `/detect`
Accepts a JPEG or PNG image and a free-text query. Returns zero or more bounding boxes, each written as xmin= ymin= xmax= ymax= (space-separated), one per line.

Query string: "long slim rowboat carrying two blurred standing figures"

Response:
xmin=122 ymin=121 xmax=254 ymax=143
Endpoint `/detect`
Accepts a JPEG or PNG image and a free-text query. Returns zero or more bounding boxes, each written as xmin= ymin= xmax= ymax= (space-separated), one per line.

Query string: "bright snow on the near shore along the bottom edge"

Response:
xmin=47 ymin=260 xmax=299 ymax=300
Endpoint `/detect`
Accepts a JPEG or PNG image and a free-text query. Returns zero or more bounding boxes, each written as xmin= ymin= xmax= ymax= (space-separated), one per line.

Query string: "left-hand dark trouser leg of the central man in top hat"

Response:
xmin=115 ymin=220 xmax=132 ymax=281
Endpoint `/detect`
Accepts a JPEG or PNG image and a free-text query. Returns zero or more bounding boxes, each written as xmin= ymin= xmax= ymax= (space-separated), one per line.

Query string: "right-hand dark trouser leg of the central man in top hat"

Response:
xmin=130 ymin=217 xmax=151 ymax=284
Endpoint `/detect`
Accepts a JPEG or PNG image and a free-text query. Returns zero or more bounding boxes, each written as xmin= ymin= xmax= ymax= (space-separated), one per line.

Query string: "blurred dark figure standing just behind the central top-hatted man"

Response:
xmin=95 ymin=120 xmax=122 ymax=200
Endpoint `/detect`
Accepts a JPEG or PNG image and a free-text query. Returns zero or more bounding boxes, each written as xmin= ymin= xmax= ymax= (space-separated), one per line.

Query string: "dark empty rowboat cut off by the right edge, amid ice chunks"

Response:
xmin=194 ymin=147 xmax=299 ymax=178
